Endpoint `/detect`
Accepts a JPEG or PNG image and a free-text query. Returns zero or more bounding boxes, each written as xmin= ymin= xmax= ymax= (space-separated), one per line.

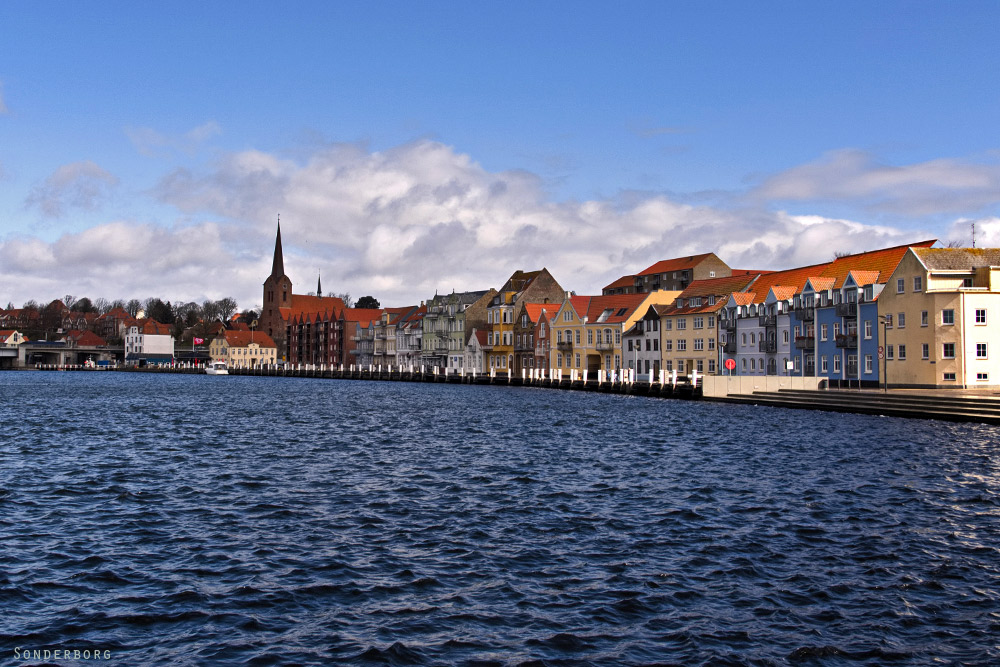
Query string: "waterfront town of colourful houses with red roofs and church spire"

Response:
xmin=0 ymin=224 xmax=1000 ymax=388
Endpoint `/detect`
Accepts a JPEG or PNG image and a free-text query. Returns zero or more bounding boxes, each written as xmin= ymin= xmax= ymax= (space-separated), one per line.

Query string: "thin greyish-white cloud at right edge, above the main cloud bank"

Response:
xmin=753 ymin=150 xmax=1000 ymax=216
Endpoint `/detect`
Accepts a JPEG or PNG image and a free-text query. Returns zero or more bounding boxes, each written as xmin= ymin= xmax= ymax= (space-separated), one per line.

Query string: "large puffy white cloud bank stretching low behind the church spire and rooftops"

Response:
xmin=0 ymin=141 xmax=952 ymax=314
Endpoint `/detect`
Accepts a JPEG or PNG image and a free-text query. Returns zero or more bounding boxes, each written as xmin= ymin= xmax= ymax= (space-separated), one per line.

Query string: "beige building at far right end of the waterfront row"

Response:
xmin=878 ymin=248 xmax=1000 ymax=388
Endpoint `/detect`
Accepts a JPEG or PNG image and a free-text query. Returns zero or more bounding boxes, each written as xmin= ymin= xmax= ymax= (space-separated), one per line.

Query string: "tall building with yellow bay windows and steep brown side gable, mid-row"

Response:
xmin=484 ymin=268 xmax=565 ymax=375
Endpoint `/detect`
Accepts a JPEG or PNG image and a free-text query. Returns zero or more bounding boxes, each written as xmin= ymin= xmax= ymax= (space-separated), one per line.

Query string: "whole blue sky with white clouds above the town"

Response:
xmin=0 ymin=0 xmax=1000 ymax=308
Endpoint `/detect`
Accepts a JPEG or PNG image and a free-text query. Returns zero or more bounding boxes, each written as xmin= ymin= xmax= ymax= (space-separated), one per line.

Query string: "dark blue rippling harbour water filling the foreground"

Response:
xmin=0 ymin=373 xmax=1000 ymax=665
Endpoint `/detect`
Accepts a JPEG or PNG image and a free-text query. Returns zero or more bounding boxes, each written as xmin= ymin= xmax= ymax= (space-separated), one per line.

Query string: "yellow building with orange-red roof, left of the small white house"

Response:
xmin=550 ymin=290 xmax=680 ymax=374
